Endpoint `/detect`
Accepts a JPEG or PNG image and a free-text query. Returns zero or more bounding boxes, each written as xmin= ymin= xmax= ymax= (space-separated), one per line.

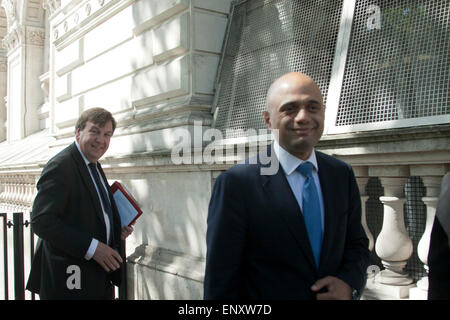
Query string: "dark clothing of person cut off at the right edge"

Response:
xmin=428 ymin=172 xmax=450 ymax=300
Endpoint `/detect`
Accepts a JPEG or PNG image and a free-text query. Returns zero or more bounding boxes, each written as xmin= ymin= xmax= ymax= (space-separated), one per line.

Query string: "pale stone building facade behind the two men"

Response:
xmin=0 ymin=0 xmax=450 ymax=299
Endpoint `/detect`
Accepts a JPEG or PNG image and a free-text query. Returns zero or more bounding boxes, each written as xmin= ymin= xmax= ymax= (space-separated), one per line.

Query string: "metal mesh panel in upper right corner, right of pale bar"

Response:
xmin=336 ymin=0 xmax=450 ymax=126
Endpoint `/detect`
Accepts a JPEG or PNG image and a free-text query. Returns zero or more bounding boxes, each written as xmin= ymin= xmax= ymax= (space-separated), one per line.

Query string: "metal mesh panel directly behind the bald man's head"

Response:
xmin=215 ymin=0 xmax=342 ymax=138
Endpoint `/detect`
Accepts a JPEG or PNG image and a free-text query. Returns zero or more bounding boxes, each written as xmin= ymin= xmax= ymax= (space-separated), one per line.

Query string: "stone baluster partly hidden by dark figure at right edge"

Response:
xmin=409 ymin=165 xmax=446 ymax=300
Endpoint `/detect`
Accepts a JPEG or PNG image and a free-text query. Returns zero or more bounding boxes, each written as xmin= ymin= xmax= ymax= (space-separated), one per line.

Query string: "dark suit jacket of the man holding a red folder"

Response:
xmin=27 ymin=143 xmax=121 ymax=299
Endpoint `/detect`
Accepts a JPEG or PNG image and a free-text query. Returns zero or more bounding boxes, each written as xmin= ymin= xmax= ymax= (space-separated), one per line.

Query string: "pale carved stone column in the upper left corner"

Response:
xmin=1 ymin=1 xmax=45 ymax=141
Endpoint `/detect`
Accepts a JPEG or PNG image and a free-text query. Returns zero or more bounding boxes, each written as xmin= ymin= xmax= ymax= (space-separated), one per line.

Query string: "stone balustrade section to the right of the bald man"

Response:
xmin=354 ymin=164 xmax=449 ymax=300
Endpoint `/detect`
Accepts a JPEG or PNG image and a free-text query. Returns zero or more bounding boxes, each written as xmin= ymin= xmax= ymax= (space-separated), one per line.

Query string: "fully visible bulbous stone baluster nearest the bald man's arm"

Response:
xmin=371 ymin=166 xmax=414 ymax=299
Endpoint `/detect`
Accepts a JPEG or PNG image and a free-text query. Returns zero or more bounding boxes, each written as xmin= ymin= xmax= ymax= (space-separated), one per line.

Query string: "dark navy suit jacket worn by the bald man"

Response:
xmin=204 ymin=148 xmax=369 ymax=299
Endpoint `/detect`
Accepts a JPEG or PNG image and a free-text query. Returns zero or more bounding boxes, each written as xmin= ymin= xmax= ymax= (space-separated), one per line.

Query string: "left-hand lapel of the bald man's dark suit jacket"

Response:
xmin=261 ymin=149 xmax=316 ymax=269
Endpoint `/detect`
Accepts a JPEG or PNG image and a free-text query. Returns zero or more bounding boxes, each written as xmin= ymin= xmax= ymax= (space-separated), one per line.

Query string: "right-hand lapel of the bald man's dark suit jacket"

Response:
xmin=316 ymin=152 xmax=338 ymax=272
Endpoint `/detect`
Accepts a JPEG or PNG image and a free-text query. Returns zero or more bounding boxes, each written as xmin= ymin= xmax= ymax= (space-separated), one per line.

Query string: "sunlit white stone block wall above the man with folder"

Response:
xmin=50 ymin=0 xmax=231 ymax=150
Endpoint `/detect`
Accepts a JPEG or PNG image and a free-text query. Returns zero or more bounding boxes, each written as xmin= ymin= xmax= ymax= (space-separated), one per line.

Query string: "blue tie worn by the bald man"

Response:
xmin=297 ymin=161 xmax=322 ymax=267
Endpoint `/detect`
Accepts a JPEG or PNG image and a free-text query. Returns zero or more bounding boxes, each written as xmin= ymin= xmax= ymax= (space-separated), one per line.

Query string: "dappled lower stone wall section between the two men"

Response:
xmin=108 ymin=172 xmax=210 ymax=299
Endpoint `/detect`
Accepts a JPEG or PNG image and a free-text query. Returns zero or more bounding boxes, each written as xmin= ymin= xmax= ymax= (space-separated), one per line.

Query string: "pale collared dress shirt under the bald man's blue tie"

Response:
xmin=273 ymin=139 xmax=325 ymax=234
